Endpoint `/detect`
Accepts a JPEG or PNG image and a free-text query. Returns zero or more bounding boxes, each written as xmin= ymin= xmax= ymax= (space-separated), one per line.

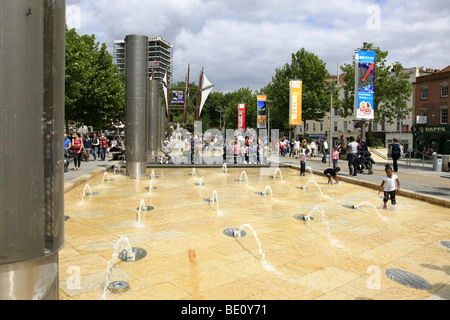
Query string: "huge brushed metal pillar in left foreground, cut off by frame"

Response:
xmin=0 ymin=0 xmax=66 ymax=300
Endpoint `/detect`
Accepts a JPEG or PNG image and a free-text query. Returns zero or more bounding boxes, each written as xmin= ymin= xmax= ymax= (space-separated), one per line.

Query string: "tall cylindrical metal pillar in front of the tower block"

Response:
xmin=125 ymin=35 xmax=148 ymax=179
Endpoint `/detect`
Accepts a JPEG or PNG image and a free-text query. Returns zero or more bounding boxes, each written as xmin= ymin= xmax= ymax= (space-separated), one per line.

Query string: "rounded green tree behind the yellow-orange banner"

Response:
xmin=263 ymin=48 xmax=330 ymax=129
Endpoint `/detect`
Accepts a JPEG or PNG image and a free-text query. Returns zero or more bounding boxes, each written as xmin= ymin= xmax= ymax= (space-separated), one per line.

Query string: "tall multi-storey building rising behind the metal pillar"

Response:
xmin=114 ymin=37 xmax=173 ymax=83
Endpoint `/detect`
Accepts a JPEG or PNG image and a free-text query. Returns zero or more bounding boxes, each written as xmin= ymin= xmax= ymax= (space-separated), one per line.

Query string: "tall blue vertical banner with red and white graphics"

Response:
xmin=355 ymin=51 xmax=375 ymax=120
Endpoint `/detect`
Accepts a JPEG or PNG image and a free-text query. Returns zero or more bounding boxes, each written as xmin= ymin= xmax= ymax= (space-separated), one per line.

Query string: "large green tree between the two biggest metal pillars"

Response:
xmin=65 ymin=27 xmax=125 ymax=129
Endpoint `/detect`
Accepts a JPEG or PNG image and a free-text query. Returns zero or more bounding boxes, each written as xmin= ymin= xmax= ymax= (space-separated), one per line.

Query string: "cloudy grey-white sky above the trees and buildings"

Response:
xmin=66 ymin=0 xmax=450 ymax=92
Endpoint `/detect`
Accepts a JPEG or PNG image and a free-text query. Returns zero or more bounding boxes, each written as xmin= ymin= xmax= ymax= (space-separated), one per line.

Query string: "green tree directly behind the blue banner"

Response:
xmin=337 ymin=43 xmax=413 ymax=124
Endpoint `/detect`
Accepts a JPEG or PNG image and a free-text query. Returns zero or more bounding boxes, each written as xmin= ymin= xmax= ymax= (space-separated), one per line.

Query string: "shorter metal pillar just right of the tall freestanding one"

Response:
xmin=147 ymin=80 xmax=161 ymax=157
